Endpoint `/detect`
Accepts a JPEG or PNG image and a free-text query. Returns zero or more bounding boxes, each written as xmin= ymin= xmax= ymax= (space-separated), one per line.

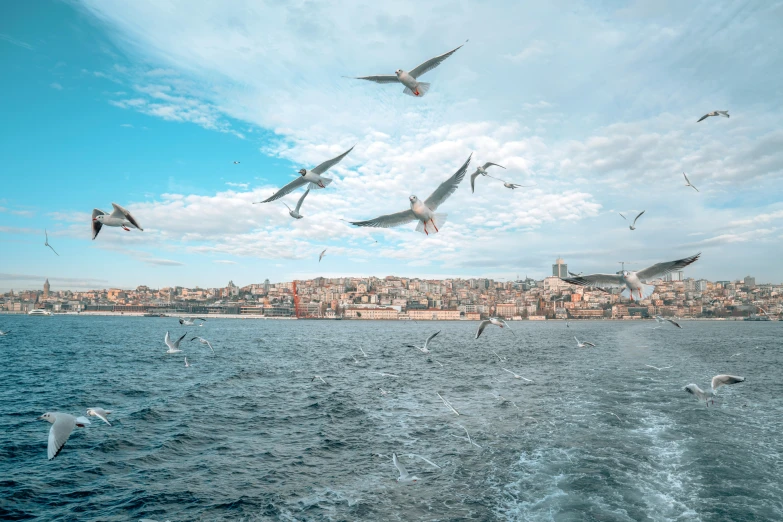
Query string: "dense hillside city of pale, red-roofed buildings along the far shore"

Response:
xmin=0 ymin=258 xmax=783 ymax=321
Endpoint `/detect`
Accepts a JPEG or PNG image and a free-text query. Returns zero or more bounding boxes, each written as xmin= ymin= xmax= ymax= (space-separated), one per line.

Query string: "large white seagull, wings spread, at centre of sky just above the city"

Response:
xmin=351 ymin=154 xmax=473 ymax=235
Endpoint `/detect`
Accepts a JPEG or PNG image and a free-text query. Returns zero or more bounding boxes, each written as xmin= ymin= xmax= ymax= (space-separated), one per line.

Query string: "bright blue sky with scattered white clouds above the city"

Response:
xmin=0 ymin=0 xmax=783 ymax=291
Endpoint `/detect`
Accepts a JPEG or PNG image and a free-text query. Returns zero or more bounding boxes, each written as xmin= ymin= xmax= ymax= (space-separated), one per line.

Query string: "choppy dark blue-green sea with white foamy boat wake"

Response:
xmin=0 ymin=316 xmax=783 ymax=522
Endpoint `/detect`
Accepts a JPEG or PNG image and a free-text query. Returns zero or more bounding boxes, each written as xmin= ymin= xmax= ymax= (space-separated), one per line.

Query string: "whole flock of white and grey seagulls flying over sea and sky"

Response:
xmin=23 ymin=41 xmax=745 ymax=476
